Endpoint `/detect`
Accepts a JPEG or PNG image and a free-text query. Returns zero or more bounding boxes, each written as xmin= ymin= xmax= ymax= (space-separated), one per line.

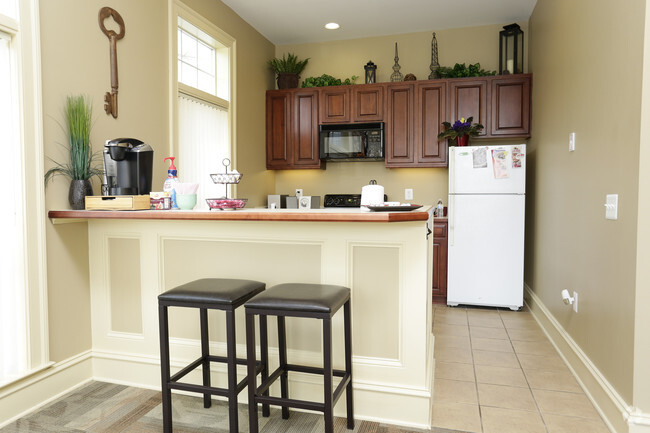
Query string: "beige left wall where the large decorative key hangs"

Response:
xmin=40 ymin=0 xmax=274 ymax=361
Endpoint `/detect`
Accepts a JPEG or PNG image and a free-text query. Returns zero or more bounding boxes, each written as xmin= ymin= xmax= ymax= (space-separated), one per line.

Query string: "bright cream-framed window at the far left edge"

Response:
xmin=0 ymin=0 xmax=49 ymax=387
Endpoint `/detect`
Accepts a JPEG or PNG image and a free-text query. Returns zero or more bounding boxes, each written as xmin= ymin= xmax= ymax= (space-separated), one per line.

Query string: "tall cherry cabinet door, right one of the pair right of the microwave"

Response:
xmin=414 ymin=81 xmax=447 ymax=167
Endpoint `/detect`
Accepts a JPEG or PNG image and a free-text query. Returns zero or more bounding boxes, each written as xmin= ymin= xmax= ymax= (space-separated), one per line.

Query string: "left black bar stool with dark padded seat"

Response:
xmin=158 ymin=278 xmax=269 ymax=433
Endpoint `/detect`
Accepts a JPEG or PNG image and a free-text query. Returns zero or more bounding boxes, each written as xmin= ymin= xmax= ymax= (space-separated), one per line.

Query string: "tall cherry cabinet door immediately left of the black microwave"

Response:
xmin=292 ymin=89 xmax=320 ymax=168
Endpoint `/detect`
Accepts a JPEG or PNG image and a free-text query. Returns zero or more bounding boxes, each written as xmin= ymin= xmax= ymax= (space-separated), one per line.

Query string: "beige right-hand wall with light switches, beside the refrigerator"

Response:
xmin=525 ymin=0 xmax=645 ymax=403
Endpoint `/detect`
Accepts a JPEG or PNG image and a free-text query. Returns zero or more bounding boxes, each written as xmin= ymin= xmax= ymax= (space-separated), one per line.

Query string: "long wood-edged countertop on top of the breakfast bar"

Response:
xmin=47 ymin=206 xmax=431 ymax=224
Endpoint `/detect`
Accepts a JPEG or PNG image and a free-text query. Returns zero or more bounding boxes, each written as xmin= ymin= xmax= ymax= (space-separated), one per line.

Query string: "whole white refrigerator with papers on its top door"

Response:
xmin=447 ymin=144 xmax=526 ymax=310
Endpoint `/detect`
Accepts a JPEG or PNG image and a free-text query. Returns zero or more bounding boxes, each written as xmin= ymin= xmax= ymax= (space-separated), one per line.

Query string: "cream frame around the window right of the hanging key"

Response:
xmin=168 ymin=0 xmax=237 ymax=184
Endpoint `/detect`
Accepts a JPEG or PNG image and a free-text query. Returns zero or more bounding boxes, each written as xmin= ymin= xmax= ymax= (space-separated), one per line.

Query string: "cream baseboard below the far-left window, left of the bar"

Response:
xmin=0 ymin=350 xmax=93 ymax=428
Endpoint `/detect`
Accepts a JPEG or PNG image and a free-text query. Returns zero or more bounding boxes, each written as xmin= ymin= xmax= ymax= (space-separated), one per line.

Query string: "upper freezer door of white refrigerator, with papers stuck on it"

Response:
xmin=449 ymin=144 xmax=526 ymax=194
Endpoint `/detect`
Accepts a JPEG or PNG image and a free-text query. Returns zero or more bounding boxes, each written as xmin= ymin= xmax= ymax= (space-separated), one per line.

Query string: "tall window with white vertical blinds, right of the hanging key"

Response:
xmin=172 ymin=3 xmax=234 ymax=209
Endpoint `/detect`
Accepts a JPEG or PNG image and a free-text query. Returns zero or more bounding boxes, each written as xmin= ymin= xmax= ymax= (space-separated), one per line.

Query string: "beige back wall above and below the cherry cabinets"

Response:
xmin=275 ymin=23 xmax=528 ymax=204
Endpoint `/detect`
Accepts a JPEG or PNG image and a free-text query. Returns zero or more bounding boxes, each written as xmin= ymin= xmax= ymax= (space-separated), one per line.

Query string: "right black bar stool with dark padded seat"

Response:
xmin=244 ymin=284 xmax=354 ymax=433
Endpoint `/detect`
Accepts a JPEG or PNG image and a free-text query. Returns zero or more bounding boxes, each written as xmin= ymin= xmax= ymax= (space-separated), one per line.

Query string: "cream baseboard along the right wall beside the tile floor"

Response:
xmin=525 ymin=284 xmax=650 ymax=433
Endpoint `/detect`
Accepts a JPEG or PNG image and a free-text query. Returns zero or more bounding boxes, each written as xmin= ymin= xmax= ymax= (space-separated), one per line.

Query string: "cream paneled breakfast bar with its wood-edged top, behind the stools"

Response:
xmin=49 ymin=209 xmax=433 ymax=428
